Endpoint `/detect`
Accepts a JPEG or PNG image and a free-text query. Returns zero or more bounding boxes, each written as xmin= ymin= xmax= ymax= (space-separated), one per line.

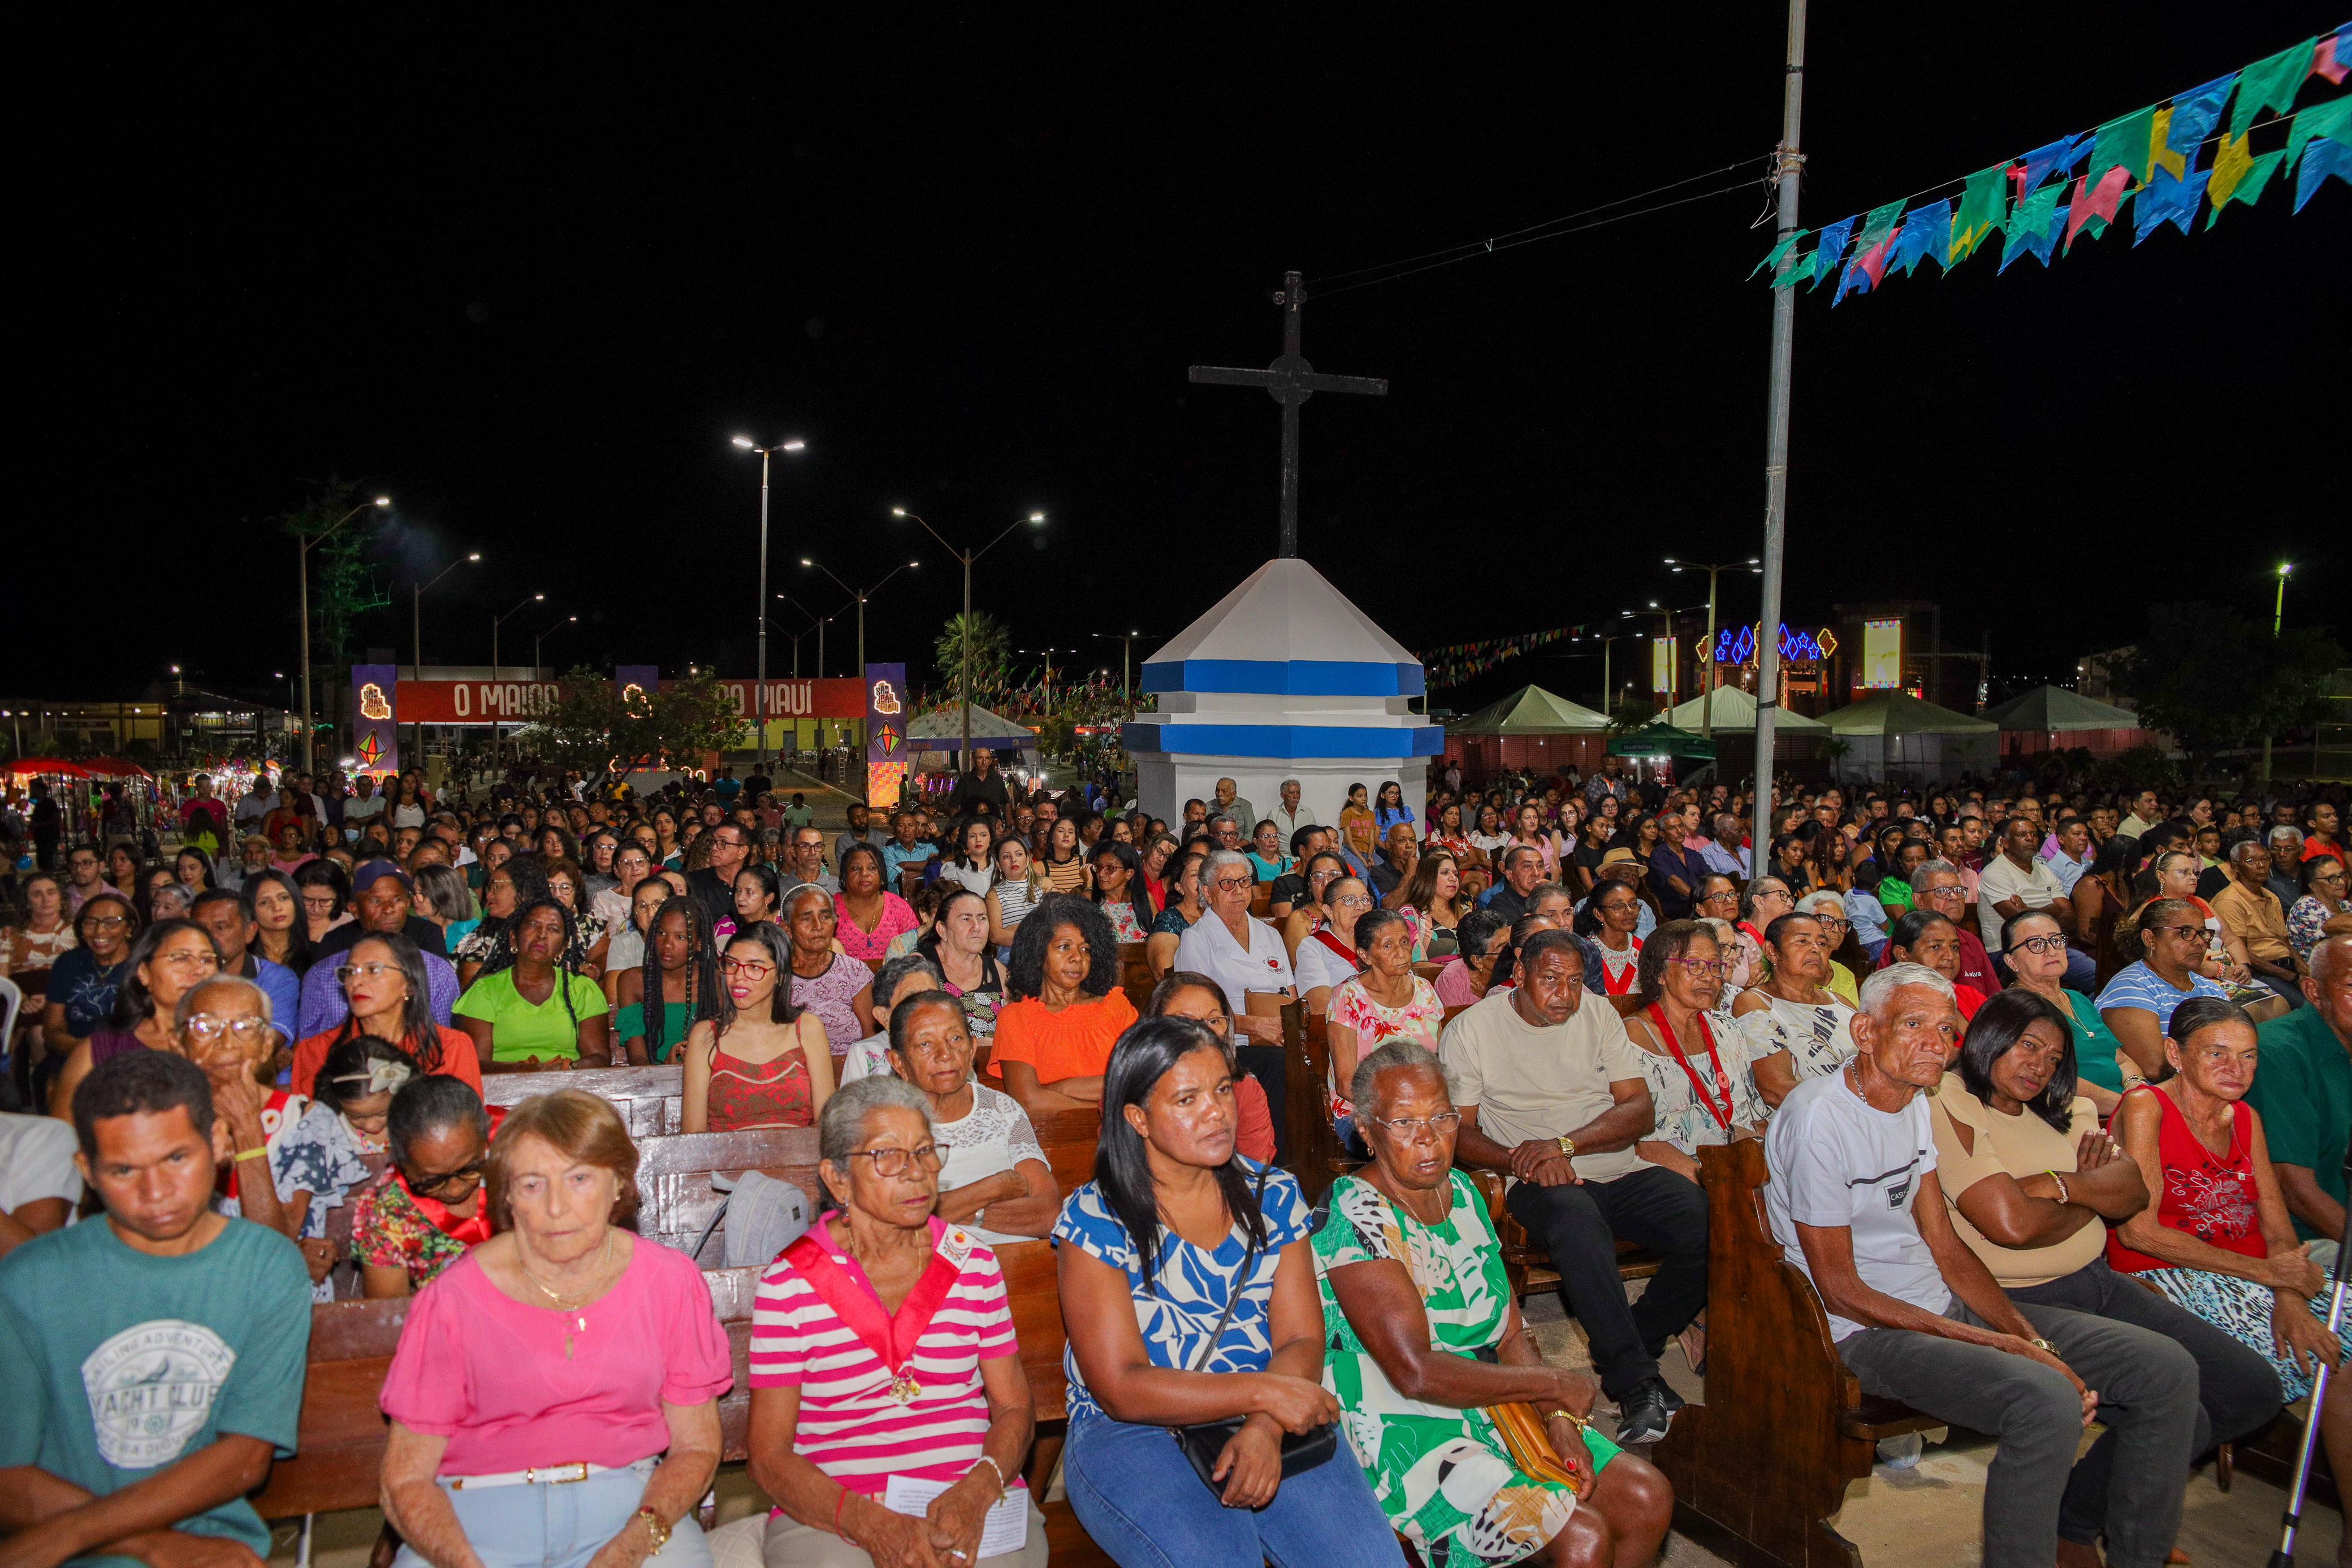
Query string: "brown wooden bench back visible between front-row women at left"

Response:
xmin=254 ymin=1241 xmax=1110 ymax=1568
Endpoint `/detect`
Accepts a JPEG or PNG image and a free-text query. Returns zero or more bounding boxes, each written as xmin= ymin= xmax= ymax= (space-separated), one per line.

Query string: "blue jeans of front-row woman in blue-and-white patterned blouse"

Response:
xmin=1063 ymin=1410 xmax=1404 ymax=1568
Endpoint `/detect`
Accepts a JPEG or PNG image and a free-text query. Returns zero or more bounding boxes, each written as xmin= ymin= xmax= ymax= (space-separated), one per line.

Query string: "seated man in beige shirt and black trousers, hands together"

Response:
xmin=1437 ymin=931 xmax=1707 ymax=1444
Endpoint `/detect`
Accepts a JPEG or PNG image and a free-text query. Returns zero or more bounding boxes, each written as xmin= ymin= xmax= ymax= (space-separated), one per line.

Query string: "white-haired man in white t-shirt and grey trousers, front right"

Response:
xmin=1764 ymin=964 xmax=2208 ymax=1568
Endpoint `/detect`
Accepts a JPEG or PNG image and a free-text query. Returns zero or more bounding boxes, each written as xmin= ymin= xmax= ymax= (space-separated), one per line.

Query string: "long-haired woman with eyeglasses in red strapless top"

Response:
xmin=680 ymin=921 xmax=833 ymax=1133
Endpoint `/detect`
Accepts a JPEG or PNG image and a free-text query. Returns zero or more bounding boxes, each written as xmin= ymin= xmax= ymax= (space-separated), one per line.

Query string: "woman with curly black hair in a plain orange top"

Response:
xmin=990 ymin=893 xmax=1136 ymax=1116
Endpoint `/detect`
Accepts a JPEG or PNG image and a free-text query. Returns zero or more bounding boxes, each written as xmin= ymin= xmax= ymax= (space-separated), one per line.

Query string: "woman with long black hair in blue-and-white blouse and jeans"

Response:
xmin=1054 ymin=1016 xmax=1399 ymax=1568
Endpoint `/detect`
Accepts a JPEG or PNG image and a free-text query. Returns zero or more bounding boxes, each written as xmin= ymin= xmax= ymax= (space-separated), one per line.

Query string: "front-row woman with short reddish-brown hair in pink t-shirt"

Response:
xmin=381 ymin=1089 xmax=734 ymax=1568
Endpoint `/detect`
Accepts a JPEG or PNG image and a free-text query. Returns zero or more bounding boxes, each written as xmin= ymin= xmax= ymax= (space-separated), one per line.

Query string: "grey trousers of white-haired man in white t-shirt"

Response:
xmin=1837 ymin=1300 xmax=2204 ymax=1568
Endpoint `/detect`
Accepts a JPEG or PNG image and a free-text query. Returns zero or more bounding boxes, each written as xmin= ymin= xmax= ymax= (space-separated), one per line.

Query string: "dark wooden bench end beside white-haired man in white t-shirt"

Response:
xmin=1651 ymin=1138 xmax=1945 ymax=1568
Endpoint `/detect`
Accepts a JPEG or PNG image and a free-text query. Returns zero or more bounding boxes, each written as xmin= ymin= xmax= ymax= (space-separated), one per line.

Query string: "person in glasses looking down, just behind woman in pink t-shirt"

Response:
xmin=351 ymin=1075 xmax=491 ymax=1300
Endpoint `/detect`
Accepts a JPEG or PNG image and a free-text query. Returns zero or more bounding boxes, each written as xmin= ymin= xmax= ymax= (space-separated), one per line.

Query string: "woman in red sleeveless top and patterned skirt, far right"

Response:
xmin=2107 ymin=997 xmax=2352 ymax=1474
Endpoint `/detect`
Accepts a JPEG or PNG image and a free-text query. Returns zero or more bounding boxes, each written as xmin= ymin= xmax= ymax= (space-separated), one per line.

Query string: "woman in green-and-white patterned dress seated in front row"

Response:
xmin=1315 ymin=1041 xmax=1675 ymax=1568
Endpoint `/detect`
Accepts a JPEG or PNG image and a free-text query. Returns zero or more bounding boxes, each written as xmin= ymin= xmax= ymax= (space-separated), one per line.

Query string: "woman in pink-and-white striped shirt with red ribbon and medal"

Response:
xmin=750 ymin=1077 xmax=1047 ymax=1568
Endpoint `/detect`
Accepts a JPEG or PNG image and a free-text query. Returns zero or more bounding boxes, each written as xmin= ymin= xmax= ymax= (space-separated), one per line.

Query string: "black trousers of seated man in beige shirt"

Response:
xmin=1505 ymin=1166 xmax=1707 ymax=1399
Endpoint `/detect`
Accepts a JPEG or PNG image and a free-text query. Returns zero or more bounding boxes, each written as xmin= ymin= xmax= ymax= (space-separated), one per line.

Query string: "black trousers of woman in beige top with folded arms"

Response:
xmin=2009 ymin=1258 xmax=2286 ymax=1540
